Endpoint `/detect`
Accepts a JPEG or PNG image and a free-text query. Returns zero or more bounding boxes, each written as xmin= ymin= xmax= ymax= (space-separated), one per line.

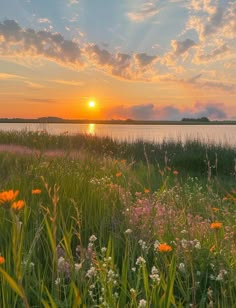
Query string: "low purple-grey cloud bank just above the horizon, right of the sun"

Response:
xmin=105 ymin=103 xmax=227 ymax=121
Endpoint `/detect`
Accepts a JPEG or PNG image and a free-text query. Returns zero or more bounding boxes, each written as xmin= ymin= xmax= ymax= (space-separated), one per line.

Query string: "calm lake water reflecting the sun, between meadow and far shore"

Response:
xmin=0 ymin=123 xmax=236 ymax=147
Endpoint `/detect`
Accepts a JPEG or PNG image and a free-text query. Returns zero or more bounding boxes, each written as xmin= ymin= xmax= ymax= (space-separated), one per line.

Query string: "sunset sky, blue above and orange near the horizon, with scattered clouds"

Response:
xmin=0 ymin=0 xmax=236 ymax=120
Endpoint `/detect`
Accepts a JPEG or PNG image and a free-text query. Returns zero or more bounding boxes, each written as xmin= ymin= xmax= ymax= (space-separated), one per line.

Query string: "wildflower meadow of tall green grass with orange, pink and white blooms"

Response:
xmin=0 ymin=131 xmax=236 ymax=308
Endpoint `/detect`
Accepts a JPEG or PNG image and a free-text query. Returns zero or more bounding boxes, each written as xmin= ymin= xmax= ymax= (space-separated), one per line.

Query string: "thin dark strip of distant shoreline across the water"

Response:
xmin=0 ymin=118 xmax=236 ymax=125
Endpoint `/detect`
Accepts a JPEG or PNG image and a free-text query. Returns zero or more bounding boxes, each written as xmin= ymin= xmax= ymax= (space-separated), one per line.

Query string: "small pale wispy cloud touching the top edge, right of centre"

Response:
xmin=127 ymin=1 xmax=159 ymax=22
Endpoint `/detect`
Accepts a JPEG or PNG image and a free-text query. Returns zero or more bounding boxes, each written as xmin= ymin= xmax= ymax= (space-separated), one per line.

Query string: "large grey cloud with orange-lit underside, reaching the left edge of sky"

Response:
xmin=0 ymin=20 xmax=82 ymax=68
